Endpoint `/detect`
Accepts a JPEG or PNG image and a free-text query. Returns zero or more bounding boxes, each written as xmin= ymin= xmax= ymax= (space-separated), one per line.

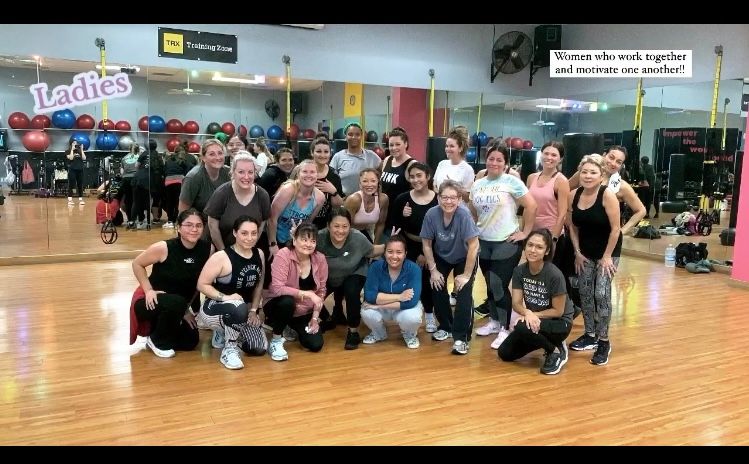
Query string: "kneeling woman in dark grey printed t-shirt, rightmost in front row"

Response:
xmin=497 ymin=229 xmax=573 ymax=375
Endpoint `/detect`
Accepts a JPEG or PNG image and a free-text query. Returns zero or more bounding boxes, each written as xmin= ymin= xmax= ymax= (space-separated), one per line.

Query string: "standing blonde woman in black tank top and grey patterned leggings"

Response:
xmin=567 ymin=155 xmax=622 ymax=365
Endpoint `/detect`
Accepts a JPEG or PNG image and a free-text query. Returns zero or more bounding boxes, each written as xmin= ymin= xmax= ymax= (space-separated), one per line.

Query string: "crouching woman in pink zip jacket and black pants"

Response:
xmin=263 ymin=222 xmax=328 ymax=361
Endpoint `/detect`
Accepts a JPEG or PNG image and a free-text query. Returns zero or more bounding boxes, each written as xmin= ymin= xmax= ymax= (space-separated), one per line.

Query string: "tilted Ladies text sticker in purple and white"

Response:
xmin=29 ymin=71 xmax=133 ymax=114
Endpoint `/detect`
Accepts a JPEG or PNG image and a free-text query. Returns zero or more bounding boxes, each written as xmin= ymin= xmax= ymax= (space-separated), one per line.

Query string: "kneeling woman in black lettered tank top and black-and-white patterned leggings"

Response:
xmin=197 ymin=215 xmax=268 ymax=369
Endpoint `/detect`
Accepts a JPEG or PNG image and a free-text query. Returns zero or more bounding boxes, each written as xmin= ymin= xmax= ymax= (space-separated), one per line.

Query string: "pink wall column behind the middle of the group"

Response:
xmin=392 ymin=87 xmax=426 ymax=161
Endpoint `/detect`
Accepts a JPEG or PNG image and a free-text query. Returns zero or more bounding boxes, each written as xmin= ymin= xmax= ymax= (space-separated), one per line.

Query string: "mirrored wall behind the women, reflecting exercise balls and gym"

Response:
xmin=0 ymin=51 xmax=745 ymax=268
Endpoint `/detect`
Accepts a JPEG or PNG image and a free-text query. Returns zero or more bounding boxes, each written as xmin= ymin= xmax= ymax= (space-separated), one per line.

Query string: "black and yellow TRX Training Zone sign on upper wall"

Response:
xmin=159 ymin=27 xmax=237 ymax=64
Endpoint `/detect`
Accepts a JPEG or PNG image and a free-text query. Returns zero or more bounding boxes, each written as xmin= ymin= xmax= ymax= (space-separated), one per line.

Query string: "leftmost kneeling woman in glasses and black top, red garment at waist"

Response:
xmin=130 ymin=209 xmax=211 ymax=358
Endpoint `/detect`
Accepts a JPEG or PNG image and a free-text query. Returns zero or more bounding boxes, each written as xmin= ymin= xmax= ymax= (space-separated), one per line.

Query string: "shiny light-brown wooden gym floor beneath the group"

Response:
xmin=0 ymin=256 xmax=749 ymax=445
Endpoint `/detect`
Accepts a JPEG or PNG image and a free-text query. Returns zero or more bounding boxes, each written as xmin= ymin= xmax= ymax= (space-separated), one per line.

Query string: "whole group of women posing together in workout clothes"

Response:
xmin=131 ymin=124 xmax=644 ymax=374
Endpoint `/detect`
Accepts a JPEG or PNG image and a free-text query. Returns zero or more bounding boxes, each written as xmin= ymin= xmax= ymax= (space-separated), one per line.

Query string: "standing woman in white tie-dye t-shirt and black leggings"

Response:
xmin=468 ymin=141 xmax=537 ymax=349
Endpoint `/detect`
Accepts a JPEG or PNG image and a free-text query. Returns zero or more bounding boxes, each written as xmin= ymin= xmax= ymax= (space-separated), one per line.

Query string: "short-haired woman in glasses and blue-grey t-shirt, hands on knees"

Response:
xmin=420 ymin=179 xmax=479 ymax=355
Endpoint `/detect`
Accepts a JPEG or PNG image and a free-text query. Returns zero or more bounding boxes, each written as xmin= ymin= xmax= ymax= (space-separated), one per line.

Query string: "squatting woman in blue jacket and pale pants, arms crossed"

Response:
xmin=362 ymin=234 xmax=422 ymax=349
